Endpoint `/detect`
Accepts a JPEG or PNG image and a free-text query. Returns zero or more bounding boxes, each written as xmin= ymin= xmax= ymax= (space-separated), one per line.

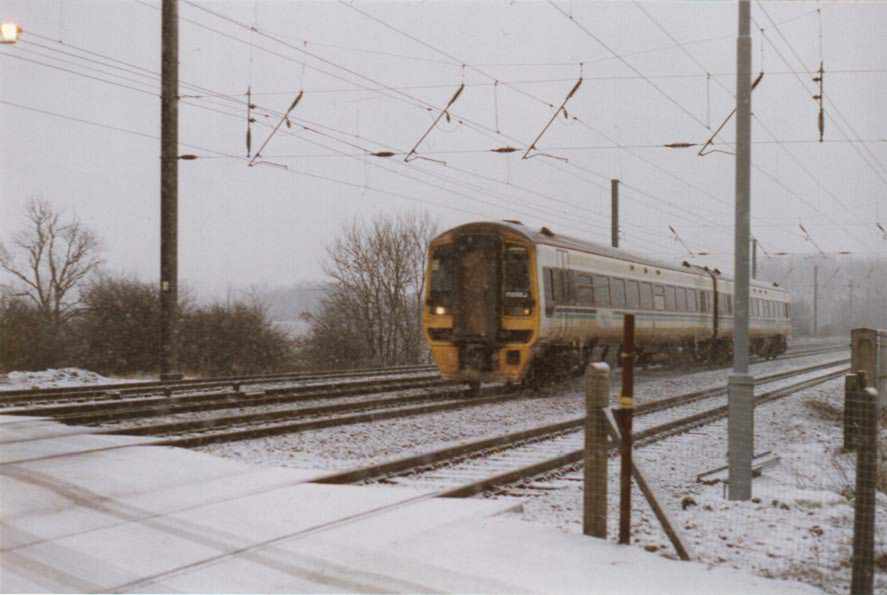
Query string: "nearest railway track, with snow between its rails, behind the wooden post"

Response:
xmin=317 ymin=360 xmax=846 ymax=497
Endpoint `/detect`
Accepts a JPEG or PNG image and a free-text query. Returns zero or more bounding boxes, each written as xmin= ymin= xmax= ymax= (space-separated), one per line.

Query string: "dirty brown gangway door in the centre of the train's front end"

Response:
xmin=456 ymin=235 xmax=502 ymax=343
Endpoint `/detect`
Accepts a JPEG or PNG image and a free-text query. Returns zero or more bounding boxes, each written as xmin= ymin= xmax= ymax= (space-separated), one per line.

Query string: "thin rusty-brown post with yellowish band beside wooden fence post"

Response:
xmin=614 ymin=314 xmax=634 ymax=545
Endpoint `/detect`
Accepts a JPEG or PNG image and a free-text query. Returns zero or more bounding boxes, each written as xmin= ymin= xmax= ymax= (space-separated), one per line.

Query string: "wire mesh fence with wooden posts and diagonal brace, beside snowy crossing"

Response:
xmin=583 ymin=352 xmax=887 ymax=594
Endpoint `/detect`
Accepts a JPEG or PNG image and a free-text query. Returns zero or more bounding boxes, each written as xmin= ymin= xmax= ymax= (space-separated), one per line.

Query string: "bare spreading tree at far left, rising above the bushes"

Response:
xmin=0 ymin=199 xmax=101 ymax=326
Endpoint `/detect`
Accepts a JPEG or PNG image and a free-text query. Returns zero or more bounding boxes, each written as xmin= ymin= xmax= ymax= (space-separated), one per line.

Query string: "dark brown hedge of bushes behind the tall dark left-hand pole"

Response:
xmin=9 ymin=275 xmax=291 ymax=375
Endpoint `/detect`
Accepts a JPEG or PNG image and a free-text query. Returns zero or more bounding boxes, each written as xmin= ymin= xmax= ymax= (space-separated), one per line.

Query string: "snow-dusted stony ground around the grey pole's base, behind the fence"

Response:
xmin=522 ymin=379 xmax=887 ymax=593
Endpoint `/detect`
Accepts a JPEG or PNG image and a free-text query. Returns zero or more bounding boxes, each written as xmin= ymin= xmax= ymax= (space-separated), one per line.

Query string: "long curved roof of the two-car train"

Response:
xmin=441 ymin=220 xmax=785 ymax=291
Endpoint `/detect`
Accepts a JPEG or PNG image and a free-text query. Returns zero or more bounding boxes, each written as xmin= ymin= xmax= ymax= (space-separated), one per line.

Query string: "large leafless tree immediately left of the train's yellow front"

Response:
xmin=308 ymin=213 xmax=436 ymax=365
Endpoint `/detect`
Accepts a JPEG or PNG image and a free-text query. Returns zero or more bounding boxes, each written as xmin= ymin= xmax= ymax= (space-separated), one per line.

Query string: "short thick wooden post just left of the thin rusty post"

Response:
xmin=582 ymin=363 xmax=610 ymax=539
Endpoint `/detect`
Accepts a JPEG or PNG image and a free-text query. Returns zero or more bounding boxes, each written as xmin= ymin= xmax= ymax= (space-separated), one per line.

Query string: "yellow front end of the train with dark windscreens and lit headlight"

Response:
xmin=423 ymin=224 xmax=539 ymax=383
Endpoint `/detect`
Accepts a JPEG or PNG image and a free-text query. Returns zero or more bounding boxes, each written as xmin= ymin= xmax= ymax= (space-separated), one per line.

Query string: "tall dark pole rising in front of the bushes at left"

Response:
xmin=160 ymin=0 xmax=181 ymax=380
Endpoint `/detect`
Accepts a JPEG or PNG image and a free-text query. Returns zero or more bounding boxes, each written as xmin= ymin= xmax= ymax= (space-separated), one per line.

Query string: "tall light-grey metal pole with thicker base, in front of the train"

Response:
xmin=727 ymin=0 xmax=754 ymax=500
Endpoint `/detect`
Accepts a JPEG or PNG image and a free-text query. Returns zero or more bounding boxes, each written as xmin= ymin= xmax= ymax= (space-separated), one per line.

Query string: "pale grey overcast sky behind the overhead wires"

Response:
xmin=0 ymin=0 xmax=887 ymax=297
